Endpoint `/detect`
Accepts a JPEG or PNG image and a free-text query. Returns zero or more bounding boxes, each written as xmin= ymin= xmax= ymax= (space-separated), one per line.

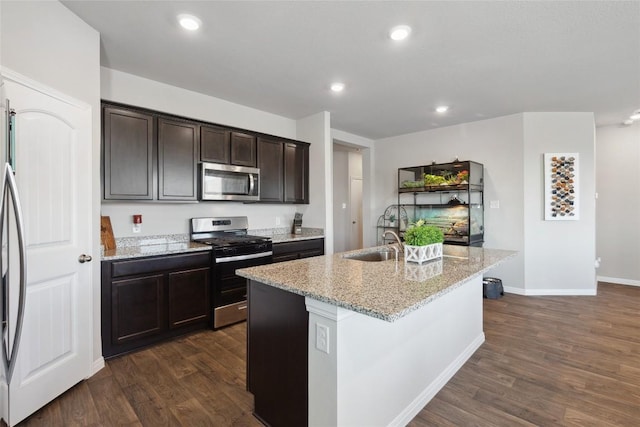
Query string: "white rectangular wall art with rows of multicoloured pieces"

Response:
xmin=544 ymin=153 xmax=580 ymax=221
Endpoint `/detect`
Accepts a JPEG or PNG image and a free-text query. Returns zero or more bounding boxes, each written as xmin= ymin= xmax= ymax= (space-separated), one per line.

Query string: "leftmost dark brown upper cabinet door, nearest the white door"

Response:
xmin=102 ymin=107 xmax=155 ymax=200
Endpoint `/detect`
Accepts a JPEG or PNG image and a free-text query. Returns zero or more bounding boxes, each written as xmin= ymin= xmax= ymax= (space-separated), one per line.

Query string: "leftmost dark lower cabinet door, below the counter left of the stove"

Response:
xmin=111 ymin=274 xmax=166 ymax=345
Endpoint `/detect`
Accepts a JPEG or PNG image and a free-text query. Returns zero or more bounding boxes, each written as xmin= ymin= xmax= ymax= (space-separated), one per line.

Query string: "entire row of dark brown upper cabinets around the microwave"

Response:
xmin=102 ymin=102 xmax=309 ymax=204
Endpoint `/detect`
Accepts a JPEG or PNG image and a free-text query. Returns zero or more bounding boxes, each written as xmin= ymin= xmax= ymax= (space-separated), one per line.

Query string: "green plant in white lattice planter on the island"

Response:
xmin=404 ymin=219 xmax=444 ymax=264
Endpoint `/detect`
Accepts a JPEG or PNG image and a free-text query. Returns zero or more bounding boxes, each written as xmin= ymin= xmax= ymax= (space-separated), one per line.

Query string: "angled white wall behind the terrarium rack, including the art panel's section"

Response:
xmin=369 ymin=113 xmax=596 ymax=295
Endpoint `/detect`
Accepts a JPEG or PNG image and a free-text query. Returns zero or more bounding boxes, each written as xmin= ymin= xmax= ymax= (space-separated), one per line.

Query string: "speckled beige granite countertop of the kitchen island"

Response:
xmin=236 ymin=245 xmax=517 ymax=322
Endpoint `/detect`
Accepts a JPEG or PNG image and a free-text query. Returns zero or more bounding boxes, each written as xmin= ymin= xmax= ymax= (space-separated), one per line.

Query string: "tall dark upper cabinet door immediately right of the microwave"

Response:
xmin=258 ymin=138 xmax=284 ymax=202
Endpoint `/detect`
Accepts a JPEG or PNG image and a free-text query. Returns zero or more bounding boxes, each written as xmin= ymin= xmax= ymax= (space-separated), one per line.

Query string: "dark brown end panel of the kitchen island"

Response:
xmin=247 ymin=280 xmax=309 ymax=427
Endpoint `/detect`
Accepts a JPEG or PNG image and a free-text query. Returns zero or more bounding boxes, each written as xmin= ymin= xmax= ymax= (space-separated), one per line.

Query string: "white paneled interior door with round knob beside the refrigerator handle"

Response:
xmin=5 ymin=76 xmax=92 ymax=425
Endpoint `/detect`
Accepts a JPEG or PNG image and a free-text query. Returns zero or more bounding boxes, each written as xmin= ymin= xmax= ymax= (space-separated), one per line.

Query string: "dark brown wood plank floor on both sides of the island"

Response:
xmin=21 ymin=283 xmax=640 ymax=427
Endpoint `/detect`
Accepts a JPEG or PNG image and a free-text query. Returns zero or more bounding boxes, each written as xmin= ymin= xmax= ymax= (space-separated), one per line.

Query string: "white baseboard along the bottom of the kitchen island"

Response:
xmin=389 ymin=332 xmax=484 ymax=426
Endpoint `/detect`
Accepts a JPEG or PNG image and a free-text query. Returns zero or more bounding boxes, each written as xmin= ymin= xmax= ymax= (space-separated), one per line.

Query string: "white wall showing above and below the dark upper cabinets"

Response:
xmin=101 ymin=67 xmax=325 ymax=237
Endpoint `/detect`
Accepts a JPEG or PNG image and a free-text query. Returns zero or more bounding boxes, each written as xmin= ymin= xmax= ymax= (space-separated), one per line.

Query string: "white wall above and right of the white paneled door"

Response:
xmin=0 ymin=1 xmax=102 ymax=365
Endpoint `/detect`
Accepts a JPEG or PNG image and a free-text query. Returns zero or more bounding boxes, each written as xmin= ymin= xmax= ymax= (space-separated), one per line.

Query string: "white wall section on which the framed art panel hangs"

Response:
xmin=523 ymin=113 xmax=596 ymax=295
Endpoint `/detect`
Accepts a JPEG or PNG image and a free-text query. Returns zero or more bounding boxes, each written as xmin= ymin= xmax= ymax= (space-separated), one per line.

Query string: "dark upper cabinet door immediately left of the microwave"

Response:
xmin=158 ymin=119 xmax=200 ymax=200
